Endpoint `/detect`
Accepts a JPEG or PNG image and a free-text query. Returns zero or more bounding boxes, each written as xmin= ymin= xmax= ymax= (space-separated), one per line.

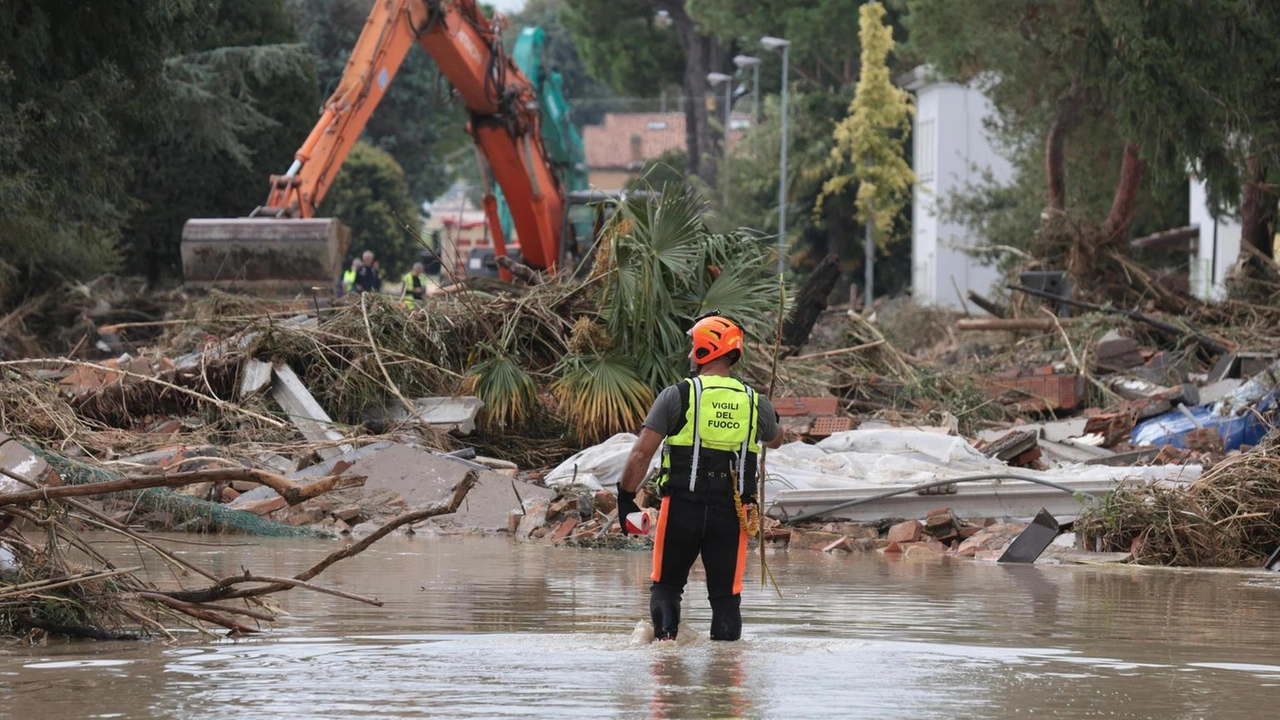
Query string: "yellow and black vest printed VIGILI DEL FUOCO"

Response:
xmin=658 ymin=375 xmax=760 ymax=497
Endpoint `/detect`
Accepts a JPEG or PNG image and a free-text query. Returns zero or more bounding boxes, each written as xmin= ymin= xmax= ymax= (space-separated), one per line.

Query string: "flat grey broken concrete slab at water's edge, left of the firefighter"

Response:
xmin=348 ymin=445 xmax=553 ymax=530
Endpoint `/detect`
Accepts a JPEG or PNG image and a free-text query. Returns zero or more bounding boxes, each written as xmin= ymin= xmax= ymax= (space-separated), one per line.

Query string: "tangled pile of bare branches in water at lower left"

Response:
xmin=0 ymin=438 xmax=477 ymax=642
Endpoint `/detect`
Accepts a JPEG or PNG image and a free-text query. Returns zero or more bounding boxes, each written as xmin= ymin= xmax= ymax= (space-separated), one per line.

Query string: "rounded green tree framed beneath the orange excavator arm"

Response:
xmin=319 ymin=142 xmax=420 ymax=273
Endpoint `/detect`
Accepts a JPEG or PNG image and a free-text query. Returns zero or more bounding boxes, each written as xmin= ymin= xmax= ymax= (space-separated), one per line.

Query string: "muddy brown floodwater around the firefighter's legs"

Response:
xmin=0 ymin=537 xmax=1280 ymax=720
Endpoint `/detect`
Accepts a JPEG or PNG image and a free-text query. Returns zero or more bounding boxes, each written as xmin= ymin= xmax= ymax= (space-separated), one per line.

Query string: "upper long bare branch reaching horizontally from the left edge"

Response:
xmin=0 ymin=468 xmax=366 ymax=507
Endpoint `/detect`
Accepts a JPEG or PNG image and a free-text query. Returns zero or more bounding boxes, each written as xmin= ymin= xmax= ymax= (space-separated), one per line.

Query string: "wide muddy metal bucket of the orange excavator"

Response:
xmin=182 ymin=218 xmax=351 ymax=295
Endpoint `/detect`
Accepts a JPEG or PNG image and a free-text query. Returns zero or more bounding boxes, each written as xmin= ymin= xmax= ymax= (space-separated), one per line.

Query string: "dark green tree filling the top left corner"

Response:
xmin=0 ymin=0 xmax=205 ymax=300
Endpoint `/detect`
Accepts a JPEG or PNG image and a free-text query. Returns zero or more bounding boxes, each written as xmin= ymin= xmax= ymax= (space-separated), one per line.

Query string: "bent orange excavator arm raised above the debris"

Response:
xmin=253 ymin=0 xmax=564 ymax=270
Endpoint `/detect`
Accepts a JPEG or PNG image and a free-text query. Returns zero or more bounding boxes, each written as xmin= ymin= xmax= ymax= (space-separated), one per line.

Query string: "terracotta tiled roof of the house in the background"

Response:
xmin=582 ymin=113 xmax=750 ymax=170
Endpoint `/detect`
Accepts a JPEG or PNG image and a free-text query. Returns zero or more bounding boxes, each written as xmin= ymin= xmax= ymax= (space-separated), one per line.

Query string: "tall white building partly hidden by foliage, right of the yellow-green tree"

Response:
xmin=901 ymin=68 xmax=1014 ymax=310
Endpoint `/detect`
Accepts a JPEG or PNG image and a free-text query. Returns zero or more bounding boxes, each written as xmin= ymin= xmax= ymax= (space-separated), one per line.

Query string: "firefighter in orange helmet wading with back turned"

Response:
xmin=618 ymin=314 xmax=782 ymax=641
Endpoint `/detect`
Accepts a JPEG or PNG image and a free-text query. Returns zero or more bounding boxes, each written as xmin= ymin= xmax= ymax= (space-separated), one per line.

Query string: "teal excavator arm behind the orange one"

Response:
xmin=495 ymin=27 xmax=591 ymax=254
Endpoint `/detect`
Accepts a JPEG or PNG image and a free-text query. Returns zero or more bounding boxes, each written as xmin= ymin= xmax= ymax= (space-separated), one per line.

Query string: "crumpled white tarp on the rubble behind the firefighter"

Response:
xmin=547 ymin=428 xmax=1201 ymax=501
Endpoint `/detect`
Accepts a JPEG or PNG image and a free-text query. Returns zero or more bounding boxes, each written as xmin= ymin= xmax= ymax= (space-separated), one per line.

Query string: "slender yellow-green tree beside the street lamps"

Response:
xmin=817 ymin=3 xmax=915 ymax=247
